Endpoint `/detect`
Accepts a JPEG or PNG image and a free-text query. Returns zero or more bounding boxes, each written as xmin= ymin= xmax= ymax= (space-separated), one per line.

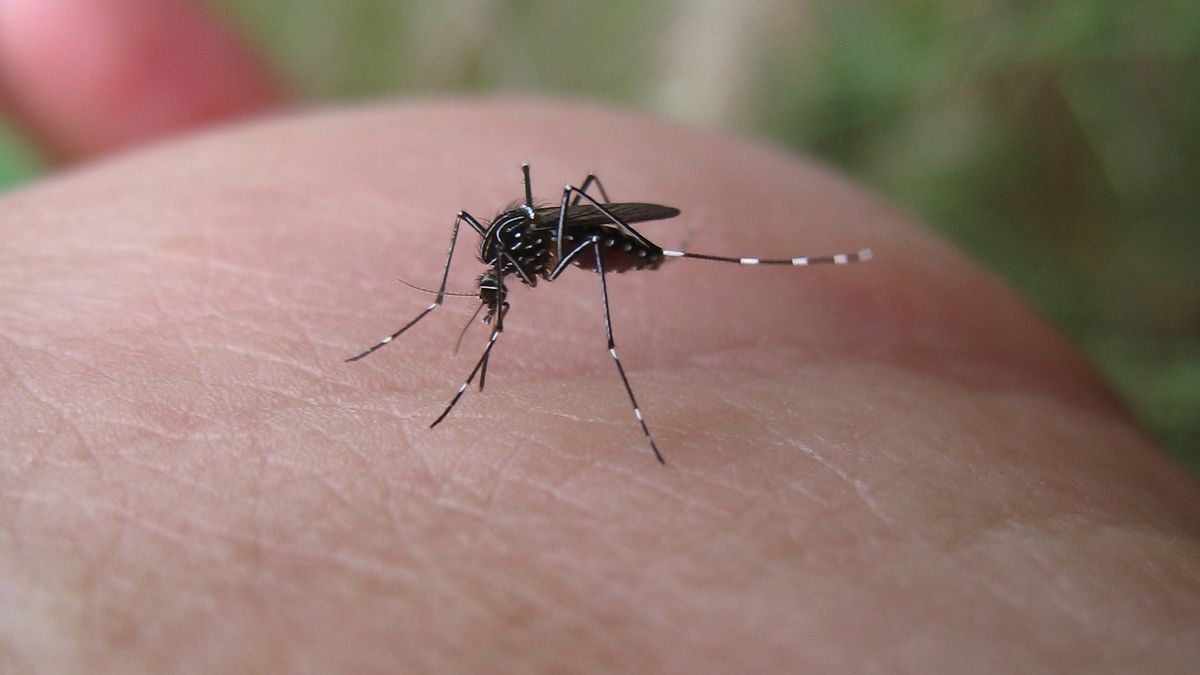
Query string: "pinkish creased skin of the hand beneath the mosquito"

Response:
xmin=0 ymin=102 xmax=1200 ymax=673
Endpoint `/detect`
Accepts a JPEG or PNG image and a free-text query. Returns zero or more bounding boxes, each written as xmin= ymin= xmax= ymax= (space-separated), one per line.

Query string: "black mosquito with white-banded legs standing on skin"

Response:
xmin=346 ymin=165 xmax=871 ymax=464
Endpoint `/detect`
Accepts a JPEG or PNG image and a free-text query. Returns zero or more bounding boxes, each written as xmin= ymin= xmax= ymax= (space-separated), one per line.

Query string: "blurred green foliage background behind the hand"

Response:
xmin=0 ymin=0 xmax=1200 ymax=470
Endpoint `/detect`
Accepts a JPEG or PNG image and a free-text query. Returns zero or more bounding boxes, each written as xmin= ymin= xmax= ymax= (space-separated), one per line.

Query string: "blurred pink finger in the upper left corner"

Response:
xmin=0 ymin=0 xmax=283 ymax=160
